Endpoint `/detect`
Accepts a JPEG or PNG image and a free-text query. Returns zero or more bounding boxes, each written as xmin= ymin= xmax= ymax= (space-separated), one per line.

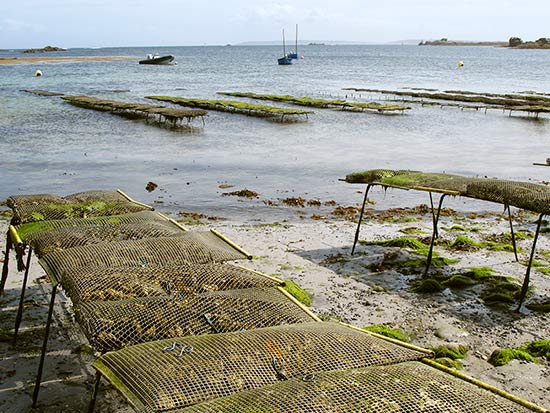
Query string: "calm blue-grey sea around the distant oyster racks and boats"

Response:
xmin=0 ymin=45 xmax=550 ymax=220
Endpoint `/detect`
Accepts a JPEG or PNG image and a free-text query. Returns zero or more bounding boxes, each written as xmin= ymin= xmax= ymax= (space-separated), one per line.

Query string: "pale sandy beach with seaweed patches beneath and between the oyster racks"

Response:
xmin=0 ymin=197 xmax=550 ymax=413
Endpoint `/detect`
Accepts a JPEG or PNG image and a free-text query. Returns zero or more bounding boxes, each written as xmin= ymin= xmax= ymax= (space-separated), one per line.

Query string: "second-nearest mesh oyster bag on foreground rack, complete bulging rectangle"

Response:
xmin=94 ymin=322 xmax=432 ymax=412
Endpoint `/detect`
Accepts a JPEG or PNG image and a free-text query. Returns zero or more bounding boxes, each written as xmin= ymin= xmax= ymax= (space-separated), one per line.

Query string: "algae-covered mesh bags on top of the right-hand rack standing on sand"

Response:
xmin=346 ymin=169 xmax=550 ymax=214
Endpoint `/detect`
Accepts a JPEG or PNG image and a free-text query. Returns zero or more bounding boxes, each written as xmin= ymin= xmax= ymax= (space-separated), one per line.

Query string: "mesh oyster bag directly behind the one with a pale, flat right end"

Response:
xmin=27 ymin=220 xmax=184 ymax=257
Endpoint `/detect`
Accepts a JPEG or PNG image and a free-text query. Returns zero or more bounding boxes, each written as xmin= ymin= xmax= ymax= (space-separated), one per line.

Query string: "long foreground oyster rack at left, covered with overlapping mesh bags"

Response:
xmin=3 ymin=187 xmax=546 ymax=413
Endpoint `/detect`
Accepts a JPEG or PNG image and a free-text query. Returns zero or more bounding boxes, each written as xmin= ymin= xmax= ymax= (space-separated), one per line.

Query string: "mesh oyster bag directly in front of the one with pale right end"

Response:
xmin=59 ymin=264 xmax=281 ymax=304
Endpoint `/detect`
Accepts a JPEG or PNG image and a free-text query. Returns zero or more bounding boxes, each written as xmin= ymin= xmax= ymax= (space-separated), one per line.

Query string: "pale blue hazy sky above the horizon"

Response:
xmin=0 ymin=0 xmax=550 ymax=49
